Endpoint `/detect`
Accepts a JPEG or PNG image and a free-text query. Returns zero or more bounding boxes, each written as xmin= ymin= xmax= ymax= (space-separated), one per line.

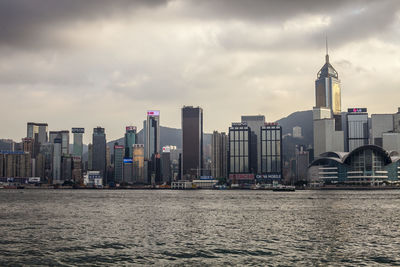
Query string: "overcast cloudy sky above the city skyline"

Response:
xmin=0 ymin=0 xmax=400 ymax=143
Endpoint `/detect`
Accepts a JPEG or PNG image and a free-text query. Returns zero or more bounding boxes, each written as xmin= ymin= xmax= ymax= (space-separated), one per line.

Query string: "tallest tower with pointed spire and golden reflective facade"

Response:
xmin=315 ymin=42 xmax=342 ymax=130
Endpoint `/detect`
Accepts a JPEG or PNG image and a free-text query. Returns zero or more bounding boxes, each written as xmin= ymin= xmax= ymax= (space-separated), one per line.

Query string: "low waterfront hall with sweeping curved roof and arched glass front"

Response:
xmin=309 ymin=145 xmax=400 ymax=185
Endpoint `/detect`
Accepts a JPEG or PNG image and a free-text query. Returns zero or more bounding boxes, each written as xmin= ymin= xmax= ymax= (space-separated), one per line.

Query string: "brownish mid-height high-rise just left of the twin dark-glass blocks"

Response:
xmin=211 ymin=131 xmax=228 ymax=178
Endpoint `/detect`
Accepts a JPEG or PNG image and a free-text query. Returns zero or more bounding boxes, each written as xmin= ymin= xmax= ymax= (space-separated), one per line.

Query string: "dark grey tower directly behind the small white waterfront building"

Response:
xmin=92 ymin=127 xmax=107 ymax=185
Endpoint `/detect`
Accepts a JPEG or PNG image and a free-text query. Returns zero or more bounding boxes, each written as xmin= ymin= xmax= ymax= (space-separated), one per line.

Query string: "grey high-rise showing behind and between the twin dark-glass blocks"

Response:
xmin=242 ymin=115 xmax=265 ymax=173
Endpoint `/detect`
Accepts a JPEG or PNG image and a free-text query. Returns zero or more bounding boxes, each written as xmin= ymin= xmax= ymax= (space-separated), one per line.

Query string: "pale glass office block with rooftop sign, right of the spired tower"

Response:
xmin=345 ymin=108 xmax=369 ymax=152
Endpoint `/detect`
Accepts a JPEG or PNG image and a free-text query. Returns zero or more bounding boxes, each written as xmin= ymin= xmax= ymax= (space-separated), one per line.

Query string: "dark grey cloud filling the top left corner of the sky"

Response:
xmin=0 ymin=0 xmax=166 ymax=47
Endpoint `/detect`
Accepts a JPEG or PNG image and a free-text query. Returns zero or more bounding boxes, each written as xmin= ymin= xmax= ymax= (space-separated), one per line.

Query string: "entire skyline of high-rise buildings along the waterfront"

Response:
xmin=0 ymin=49 xmax=400 ymax=187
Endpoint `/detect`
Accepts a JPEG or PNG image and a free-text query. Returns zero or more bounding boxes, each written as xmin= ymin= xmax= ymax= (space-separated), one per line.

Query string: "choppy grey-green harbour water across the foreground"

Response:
xmin=0 ymin=190 xmax=400 ymax=266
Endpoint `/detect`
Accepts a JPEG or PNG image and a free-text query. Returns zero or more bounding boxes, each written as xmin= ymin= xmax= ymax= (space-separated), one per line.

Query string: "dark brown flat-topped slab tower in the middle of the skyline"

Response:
xmin=182 ymin=106 xmax=203 ymax=180
